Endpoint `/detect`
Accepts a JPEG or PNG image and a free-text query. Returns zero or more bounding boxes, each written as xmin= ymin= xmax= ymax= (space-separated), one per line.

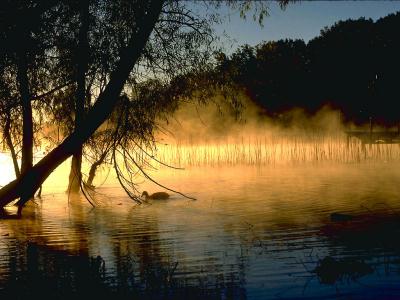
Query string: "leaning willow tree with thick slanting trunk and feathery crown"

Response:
xmin=0 ymin=0 xmax=282 ymax=208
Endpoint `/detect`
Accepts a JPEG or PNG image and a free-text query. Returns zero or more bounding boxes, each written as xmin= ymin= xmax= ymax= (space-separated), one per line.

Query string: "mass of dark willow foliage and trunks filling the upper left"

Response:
xmin=0 ymin=0 xmax=285 ymax=207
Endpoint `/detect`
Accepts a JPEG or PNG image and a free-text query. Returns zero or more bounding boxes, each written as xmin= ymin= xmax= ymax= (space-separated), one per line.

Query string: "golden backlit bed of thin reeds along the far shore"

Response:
xmin=157 ymin=134 xmax=400 ymax=167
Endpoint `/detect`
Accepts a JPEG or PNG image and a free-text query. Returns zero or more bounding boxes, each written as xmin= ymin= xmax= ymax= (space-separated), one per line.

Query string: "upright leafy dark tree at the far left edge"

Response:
xmin=0 ymin=1 xmax=60 ymax=178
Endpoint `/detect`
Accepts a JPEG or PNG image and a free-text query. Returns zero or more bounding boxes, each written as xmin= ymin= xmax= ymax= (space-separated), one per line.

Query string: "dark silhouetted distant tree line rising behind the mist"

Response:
xmin=217 ymin=12 xmax=400 ymax=125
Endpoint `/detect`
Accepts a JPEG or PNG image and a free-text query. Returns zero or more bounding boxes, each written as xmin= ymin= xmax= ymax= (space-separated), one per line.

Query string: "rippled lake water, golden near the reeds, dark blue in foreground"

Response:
xmin=0 ymin=164 xmax=400 ymax=299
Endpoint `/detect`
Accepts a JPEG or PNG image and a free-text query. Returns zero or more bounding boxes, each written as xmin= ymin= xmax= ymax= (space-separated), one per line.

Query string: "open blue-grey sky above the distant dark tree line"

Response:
xmin=212 ymin=1 xmax=400 ymax=52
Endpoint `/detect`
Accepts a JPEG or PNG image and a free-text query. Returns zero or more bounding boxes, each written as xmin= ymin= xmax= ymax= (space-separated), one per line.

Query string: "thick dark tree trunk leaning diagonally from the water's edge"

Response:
xmin=0 ymin=0 xmax=162 ymax=211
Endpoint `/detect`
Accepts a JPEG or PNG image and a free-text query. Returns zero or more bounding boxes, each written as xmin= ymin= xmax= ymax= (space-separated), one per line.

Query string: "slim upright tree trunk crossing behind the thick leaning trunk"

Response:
xmin=68 ymin=0 xmax=89 ymax=193
